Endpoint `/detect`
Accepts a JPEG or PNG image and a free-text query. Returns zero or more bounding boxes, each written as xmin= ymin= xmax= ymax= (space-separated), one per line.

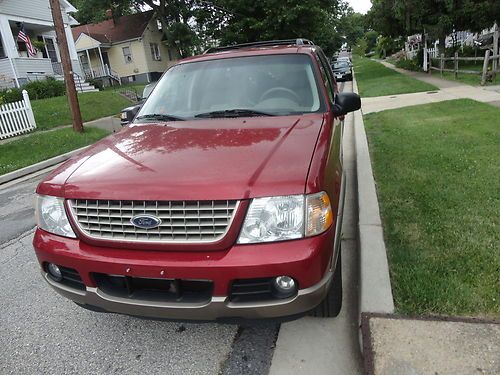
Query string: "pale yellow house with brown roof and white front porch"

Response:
xmin=72 ymin=11 xmax=178 ymax=85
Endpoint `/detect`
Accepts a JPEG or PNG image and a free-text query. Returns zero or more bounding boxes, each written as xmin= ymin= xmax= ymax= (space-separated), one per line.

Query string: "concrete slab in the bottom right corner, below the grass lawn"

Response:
xmin=363 ymin=315 xmax=500 ymax=375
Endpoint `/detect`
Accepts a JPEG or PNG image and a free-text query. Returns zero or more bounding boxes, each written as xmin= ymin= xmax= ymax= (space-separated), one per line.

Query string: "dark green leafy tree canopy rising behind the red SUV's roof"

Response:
xmin=73 ymin=0 xmax=365 ymax=56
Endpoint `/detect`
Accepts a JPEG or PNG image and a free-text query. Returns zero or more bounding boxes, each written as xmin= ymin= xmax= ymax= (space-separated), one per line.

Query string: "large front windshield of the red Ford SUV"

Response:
xmin=137 ymin=55 xmax=322 ymax=119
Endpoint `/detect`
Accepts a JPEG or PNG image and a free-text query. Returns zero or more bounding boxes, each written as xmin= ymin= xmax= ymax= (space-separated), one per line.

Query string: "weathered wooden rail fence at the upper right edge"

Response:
xmin=429 ymin=50 xmax=500 ymax=85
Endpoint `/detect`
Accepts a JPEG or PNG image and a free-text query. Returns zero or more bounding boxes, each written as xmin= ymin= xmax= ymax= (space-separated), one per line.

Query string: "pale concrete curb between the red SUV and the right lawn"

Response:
xmin=353 ymin=78 xmax=394 ymax=324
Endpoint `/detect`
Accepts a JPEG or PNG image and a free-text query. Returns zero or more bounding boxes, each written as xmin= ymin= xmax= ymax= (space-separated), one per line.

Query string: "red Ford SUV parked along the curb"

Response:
xmin=33 ymin=39 xmax=361 ymax=320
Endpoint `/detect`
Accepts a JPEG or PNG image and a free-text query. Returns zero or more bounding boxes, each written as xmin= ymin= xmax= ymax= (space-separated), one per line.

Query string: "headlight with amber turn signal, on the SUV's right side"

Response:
xmin=238 ymin=192 xmax=333 ymax=244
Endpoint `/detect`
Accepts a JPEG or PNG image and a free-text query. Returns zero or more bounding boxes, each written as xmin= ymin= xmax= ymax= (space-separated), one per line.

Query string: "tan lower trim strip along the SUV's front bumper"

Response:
xmin=42 ymin=271 xmax=333 ymax=320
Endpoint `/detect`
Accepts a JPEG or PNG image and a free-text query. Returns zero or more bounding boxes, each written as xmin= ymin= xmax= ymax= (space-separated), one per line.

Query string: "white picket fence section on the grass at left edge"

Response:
xmin=0 ymin=90 xmax=36 ymax=139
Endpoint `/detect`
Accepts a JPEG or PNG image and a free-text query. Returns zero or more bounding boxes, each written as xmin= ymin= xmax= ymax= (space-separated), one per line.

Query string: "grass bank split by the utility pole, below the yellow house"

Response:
xmin=31 ymin=91 xmax=130 ymax=130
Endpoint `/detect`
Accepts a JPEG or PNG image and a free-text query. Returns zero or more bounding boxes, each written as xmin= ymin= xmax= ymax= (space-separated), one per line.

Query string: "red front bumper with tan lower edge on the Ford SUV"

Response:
xmin=33 ymin=226 xmax=336 ymax=320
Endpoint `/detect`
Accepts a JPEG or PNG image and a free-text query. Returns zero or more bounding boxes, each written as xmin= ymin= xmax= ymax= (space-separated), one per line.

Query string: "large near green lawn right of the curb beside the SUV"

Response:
xmin=365 ymin=99 xmax=500 ymax=317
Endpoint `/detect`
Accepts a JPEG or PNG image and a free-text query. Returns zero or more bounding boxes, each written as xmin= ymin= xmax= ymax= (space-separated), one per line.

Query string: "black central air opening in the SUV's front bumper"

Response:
xmin=92 ymin=273 xmax=213 ymax=303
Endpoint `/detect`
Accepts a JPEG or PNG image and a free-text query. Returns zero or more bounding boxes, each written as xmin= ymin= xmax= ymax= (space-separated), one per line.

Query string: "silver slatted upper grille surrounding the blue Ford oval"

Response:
xmin=69 ymin=199 xmax=238 ymax=243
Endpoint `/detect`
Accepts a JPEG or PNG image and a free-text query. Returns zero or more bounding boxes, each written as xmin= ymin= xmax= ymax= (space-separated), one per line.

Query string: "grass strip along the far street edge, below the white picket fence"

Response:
xmin=0 ymin=127 xmax=109 ymax=175
